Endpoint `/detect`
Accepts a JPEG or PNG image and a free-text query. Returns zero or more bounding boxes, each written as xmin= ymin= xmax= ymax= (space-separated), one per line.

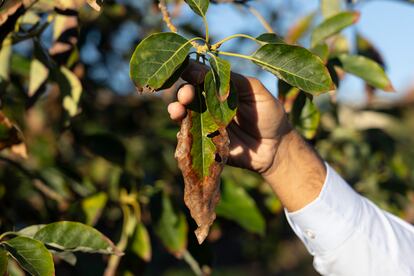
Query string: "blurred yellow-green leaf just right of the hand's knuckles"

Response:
xmin=290 ymin=92 xmax=321 ymax=139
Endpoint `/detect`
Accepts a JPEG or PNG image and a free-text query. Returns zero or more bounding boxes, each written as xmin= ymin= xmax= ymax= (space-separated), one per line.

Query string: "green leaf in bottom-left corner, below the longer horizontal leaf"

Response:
xmin=3 ymin=237 xmax=55 ymax=276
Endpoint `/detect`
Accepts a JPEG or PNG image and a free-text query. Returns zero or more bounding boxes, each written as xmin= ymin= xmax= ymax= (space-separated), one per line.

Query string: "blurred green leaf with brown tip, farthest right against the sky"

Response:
xmin=338 ymin=54 xmax=394 ymax=91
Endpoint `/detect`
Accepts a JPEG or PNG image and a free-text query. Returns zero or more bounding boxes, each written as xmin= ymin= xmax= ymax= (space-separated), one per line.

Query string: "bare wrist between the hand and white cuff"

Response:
xmin=263 ymin=130 xmax=326 ymax=212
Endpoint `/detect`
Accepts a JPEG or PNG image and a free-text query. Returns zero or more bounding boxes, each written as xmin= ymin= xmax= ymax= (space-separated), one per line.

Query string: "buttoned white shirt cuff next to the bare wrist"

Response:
xmin=285 ymin=164 xmax=362 ymax=255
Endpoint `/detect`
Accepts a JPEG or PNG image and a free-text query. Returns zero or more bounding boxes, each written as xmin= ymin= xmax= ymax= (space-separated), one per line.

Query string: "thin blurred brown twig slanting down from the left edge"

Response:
xmin=0 ymin=156 xmax=69 ymax=210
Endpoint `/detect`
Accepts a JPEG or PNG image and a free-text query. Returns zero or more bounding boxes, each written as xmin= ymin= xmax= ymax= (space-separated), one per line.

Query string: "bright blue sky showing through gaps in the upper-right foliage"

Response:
xmin=184 ymin=0 xmax=414 ymax=101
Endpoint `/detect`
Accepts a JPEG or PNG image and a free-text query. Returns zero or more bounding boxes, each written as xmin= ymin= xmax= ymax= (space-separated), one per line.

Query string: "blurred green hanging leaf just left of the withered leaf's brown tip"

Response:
xmin=155 ymin=194 xmax=188 ymax=257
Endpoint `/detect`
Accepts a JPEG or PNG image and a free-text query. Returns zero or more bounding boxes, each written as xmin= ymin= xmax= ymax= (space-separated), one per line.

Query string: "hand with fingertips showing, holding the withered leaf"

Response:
xmin=168 ymin=62 xmax=292 ymax=175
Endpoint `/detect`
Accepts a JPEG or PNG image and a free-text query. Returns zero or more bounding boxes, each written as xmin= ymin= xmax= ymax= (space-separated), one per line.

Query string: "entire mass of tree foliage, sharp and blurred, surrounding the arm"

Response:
xmin=0 ymin=0 xmax=414 ymax=275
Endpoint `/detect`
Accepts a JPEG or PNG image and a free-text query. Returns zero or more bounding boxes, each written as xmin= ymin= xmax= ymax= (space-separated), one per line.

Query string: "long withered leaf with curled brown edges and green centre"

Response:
xmin=175 ymin=86 xmax=229 ymax=244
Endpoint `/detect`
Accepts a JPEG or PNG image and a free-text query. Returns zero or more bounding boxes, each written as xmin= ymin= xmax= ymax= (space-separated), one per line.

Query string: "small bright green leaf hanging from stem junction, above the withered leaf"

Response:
xmin=209 ymin=56 xmax=231 ymax=102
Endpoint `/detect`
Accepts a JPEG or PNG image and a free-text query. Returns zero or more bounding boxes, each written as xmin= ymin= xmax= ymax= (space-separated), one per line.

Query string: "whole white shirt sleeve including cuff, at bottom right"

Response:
xmin=285 ymin=164 xmax=414 ymax=276
